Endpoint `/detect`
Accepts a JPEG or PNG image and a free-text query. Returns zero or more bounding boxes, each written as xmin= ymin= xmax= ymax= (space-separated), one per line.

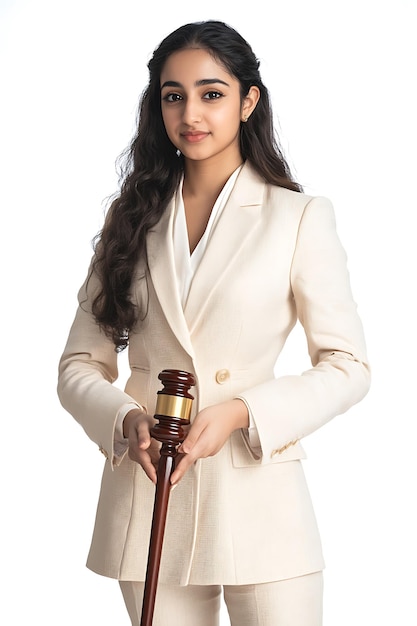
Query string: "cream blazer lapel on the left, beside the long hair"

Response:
xmin=147 ymin=197 xmax=194 ymax=357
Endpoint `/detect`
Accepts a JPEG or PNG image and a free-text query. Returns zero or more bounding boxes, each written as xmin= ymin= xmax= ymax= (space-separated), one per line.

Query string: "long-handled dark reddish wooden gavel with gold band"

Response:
xmin=140 ymin=369 xmax=195 ymax=626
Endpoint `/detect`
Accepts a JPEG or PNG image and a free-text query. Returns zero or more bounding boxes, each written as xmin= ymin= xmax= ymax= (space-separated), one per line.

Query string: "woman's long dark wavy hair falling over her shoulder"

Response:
xmin=92 ymin=20 xmax=301 ymax=351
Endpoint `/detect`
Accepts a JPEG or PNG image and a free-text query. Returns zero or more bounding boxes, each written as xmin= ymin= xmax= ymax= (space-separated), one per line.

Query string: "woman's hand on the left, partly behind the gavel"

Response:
xmin=123 ymin=409 xmax=161 ymax=484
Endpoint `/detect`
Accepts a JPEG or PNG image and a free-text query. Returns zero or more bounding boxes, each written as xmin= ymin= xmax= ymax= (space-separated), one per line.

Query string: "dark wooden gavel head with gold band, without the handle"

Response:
xmin=151 ymin=369 xmax=195 ymax=454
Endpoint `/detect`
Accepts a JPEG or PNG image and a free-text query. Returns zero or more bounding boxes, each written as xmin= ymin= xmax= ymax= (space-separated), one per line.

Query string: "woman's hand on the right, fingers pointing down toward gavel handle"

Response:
xmin=171 ymin=399 xmax=249 ymax=485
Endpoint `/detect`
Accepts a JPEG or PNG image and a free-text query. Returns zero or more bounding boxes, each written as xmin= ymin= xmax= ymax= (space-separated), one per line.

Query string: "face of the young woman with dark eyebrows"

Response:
xmin=161 ymin=48 xmax=245 ymax=164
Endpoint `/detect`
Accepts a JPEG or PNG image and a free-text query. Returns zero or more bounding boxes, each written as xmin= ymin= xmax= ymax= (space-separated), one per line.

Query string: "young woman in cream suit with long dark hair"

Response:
xmin=58 ymin=21 xmax=369 ymax=626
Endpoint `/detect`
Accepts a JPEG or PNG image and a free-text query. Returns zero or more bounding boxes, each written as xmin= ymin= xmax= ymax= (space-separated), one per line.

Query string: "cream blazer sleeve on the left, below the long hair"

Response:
xmin=57 ymin=271 xmax=140 ymax=465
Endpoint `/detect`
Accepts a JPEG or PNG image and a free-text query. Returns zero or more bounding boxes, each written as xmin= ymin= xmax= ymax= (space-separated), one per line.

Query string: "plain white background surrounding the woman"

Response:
xmin=0 ymin=0 xmax=417 ymax=626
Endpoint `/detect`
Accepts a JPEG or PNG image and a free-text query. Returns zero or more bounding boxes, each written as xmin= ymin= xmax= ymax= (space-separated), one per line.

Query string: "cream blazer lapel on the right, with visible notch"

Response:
xmin=184 ymin=164 xmax=265 ymax=333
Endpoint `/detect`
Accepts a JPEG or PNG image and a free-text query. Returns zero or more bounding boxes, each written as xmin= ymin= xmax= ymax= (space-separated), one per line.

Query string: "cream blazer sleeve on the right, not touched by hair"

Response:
xmin=240 ymin=197 xmax=370 ymax=464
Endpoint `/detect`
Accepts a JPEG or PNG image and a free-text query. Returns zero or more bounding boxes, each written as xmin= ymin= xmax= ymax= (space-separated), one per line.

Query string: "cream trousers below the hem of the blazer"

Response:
xmin=120 ymin=572 xmax=323 ymax=626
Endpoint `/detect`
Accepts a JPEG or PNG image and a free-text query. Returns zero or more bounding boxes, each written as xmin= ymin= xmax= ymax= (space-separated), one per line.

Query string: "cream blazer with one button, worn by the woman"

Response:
xmin=58 ymin=164 xmax=370 ymax=585
